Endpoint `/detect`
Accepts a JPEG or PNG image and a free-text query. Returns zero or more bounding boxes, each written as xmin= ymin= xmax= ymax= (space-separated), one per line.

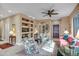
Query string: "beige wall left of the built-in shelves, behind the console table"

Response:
xmin=10 ymin=14 xmax=22 ymax=44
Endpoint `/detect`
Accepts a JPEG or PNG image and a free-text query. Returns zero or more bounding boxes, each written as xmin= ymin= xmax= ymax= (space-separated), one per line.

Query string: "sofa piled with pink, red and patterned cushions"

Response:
xmin=59 ymin=35 xmax=79 ymax=56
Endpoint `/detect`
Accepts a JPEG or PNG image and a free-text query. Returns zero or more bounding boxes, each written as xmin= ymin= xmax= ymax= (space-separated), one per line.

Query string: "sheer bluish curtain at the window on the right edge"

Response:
xmin=73 ymin=14 xmax=79 ymax=36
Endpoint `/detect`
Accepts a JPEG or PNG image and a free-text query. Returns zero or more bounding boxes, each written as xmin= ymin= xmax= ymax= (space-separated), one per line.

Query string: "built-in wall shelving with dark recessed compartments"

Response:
xmin=22 ymin=18 xmax=33 ymax=38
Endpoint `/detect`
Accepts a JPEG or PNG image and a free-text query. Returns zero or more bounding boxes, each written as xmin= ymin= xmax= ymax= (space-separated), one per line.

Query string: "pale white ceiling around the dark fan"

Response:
xmin=0 ymin=3 xmax=77 ymax=19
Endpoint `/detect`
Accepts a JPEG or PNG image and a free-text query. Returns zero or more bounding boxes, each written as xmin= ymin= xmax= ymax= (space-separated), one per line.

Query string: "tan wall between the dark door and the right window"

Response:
xmin=60 ymin=16 xmax=71 ymax=35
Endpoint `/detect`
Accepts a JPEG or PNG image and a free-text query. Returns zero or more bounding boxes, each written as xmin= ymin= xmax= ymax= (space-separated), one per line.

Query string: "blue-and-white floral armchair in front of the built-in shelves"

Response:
xmin=23 ymin=38 xmax=39 ymax=56
